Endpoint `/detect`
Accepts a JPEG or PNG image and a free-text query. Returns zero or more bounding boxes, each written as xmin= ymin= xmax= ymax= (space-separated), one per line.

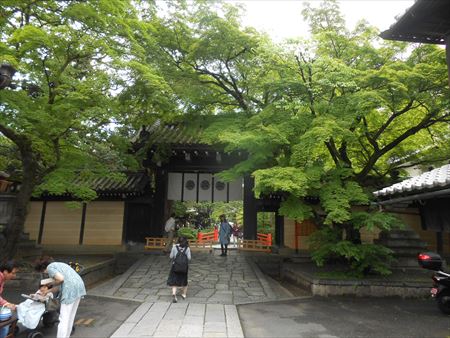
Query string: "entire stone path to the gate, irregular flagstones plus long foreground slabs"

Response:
xmin=88 ymin=252 xmax=292 ymax=337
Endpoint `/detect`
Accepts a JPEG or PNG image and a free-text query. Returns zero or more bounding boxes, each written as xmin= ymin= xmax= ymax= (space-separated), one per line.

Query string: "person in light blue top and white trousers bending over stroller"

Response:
xmin=35 ymin=257 xmax=86 ymax=338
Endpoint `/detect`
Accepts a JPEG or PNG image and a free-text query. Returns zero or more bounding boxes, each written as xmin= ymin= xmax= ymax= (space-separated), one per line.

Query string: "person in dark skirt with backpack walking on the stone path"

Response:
xmin=167 ymin=237 xmax=191 ymax=303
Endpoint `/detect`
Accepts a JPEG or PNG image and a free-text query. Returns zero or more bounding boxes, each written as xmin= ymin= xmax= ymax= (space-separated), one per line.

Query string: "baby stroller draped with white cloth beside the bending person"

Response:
xmin=18 ymin=294 xmax=59 ymax=338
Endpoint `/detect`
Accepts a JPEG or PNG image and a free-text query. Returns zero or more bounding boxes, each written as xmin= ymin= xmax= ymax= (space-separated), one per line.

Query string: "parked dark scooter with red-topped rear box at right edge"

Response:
xmin=417 ymin=252 xmax=450 ymax=315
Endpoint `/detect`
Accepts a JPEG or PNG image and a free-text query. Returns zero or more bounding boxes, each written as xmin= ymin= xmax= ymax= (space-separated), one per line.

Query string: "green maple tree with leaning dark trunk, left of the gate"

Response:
xmin=0 ymin=0 xmax=166 ymax=259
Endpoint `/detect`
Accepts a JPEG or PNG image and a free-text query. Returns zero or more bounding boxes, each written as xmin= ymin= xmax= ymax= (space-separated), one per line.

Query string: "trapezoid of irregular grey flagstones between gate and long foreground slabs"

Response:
xmin=90 ymin=252 xmax=289 ymax=305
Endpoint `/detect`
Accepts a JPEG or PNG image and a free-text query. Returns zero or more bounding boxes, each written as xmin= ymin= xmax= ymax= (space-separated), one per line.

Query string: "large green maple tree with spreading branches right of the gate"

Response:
xmin=144 ymin=1 xmax=450 ymax=273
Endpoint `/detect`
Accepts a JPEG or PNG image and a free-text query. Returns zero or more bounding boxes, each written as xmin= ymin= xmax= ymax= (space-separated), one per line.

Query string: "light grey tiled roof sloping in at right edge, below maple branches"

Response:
xmin=373 ymin=164 xmax=450 ymax=197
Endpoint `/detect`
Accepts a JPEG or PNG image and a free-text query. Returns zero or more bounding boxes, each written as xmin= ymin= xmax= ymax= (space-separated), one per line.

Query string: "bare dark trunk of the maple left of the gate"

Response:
xmin=0 ymin=146 xmax=38 ymax=261
